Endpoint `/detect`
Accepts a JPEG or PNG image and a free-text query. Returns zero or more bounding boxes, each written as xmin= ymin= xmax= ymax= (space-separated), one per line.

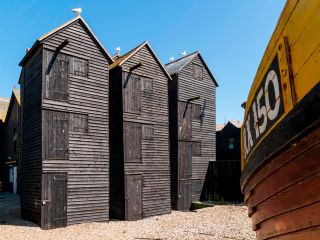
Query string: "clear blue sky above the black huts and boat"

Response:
xmin=0 ymin=0 xmax=285 ymax=123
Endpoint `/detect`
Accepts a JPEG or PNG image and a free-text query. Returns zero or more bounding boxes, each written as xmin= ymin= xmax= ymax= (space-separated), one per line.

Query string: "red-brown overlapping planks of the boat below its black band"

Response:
xmin=244 ymin=126 xmax=320 ymax=239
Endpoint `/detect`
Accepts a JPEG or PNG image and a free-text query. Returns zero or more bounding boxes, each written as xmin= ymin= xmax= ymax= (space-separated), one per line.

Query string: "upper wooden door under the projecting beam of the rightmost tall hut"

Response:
xmin=178 ymin=102 xmax=192 ymax=140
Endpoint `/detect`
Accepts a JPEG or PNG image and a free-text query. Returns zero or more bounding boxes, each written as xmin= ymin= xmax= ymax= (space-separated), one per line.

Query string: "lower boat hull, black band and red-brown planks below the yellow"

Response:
xmin=241 ymin=83 xmax=320 ymax=240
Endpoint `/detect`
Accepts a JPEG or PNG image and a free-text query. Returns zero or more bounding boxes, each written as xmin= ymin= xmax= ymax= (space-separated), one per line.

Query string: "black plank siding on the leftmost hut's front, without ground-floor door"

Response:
xmin=20 ymin=18 xmax=110 ymax=228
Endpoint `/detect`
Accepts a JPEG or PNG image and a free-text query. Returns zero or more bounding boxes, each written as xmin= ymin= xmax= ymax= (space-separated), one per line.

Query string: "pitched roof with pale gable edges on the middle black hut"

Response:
xmin=109 ymin=41 xmax=171 ymax=80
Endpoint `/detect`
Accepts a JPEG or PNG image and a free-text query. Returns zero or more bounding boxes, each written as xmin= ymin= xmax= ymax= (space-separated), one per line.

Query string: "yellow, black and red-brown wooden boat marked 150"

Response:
xmin=241 ymin=0 xmax=320 ymax=240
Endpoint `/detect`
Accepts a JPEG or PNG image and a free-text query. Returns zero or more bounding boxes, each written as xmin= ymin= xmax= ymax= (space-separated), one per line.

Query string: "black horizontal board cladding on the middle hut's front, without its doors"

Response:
xmin=111 ymin=45 xmax=170 ymax=220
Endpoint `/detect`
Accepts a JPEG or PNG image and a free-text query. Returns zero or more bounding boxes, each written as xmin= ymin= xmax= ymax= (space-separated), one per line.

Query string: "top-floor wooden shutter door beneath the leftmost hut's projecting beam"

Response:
xmin=45 ymin=51 xmax=69 ymax=100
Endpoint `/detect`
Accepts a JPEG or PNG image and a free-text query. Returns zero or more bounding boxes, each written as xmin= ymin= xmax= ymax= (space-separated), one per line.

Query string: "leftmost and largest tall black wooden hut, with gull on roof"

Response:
xmin=20 ymin=16 xmax=111 ymax=229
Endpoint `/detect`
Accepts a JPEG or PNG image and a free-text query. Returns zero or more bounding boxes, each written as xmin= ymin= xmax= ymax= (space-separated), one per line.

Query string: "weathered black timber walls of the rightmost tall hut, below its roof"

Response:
xmin=169 ymin=53 xmax=216 ymax=210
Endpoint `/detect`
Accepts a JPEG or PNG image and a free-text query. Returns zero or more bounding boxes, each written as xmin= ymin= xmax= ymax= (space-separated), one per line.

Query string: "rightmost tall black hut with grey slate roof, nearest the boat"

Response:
xmin=166 ymin=52 xmax=218 ymax=210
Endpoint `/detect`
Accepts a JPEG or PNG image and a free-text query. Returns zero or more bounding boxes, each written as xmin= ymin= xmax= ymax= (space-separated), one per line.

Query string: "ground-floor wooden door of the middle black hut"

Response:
xmin=125 ymin=174 xmax=142 ymax=221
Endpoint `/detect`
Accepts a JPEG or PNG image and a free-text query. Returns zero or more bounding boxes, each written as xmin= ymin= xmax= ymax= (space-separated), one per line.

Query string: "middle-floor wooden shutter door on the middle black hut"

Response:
xmin=123 ymin=122 xmax=142 ymax=163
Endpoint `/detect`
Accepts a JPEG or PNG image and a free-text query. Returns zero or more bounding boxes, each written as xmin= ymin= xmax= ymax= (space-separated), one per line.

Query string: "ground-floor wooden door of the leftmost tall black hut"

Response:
xmin=41 ymin=173 xmax=67 ymax=229
